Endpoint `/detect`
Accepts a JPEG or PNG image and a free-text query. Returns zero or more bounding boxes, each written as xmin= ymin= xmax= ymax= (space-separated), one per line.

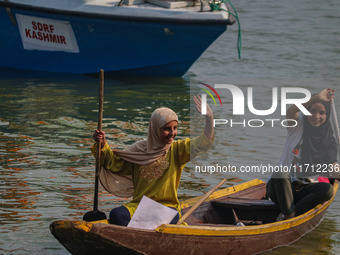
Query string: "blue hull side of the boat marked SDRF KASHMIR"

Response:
xmin=0 ymin=3 xmax=229 ymax=76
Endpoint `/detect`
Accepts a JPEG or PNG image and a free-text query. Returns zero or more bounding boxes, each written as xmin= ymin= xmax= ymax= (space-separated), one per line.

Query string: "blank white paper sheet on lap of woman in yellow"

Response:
xmin=128 ymin=196 xmax=178 ymax=230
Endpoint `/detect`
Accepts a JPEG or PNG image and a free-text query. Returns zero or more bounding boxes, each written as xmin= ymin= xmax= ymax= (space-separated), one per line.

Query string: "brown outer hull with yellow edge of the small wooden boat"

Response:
xmin=50 ymin=180 xmax=338 ymax=254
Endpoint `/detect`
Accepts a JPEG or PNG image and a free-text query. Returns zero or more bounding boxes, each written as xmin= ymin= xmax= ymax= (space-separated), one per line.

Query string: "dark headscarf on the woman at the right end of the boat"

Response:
xmin=302 ymin=102 xmax=337 ymax=166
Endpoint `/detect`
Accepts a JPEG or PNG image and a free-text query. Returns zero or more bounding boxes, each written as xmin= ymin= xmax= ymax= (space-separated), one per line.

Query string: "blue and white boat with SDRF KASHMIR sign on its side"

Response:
xmin=0 ymin=0 xmax=234 ymax=76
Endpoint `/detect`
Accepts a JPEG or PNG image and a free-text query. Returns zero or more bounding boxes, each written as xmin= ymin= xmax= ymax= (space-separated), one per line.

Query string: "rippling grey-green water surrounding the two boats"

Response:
xmin=0 ymin=0 xmax=340 ymax=254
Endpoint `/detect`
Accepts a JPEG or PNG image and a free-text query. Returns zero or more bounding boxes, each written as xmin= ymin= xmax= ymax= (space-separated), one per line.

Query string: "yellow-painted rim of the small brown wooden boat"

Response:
xmin=55 ymin=179 xmax=339 ymax=237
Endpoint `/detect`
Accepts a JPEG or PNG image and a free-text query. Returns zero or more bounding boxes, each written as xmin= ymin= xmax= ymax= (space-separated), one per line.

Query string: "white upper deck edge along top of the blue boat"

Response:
xmin=0 ymin=0 xmax=229 ymax=20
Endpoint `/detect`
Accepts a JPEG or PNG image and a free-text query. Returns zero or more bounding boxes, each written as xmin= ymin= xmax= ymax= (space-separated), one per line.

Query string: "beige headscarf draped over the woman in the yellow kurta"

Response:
xmin=99 ymin=107 xmax=178 ymax=197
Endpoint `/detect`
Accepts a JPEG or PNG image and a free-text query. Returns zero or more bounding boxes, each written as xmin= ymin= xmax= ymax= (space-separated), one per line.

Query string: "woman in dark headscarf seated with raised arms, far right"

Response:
xmin=267 ymin=89 xmax=339 ymax=220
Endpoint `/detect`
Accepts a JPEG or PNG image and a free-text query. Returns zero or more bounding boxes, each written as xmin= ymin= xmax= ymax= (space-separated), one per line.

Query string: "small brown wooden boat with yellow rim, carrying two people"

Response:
xmin=50 ymin=179 xmax=338 ymax=255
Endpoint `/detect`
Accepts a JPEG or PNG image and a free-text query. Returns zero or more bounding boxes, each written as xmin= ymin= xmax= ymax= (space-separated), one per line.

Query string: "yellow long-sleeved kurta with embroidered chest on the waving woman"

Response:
xmin=91 ymin=134 xmax=213 ymax=217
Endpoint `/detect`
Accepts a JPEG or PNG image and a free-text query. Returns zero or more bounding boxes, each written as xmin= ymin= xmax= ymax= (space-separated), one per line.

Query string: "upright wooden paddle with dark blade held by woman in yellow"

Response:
xmin=83 ymin=70 xmax=106 ymax=221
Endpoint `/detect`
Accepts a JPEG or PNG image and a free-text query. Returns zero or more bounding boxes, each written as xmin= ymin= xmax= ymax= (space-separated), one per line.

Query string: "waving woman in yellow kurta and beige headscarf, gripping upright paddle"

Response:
xmin=92 ymin=97 xmax=214 ymax=226
